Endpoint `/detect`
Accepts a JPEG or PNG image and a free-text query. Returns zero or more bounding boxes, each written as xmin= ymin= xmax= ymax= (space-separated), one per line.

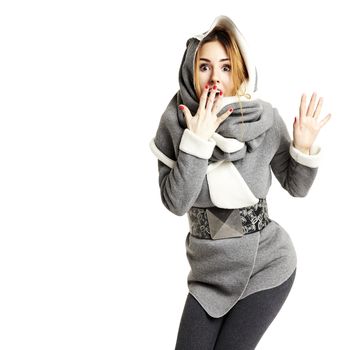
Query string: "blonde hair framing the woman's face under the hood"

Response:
xmin=193 ymin=27 xmax=249 ymax=99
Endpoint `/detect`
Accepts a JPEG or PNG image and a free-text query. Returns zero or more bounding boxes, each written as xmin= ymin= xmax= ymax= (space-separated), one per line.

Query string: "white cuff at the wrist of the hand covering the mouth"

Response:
xmin=179 ymin=128 xmax=216 ymax=159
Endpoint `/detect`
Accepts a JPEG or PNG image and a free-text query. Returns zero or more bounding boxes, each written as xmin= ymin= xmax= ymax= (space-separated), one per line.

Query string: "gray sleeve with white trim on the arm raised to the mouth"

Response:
xmin=150 ymin=129 xmax=216 ymax=216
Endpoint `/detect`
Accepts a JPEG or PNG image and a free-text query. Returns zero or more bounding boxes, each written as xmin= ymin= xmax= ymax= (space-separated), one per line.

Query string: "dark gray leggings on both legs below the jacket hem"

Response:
xmin=175 ymin=269 xmax=296 ymax=350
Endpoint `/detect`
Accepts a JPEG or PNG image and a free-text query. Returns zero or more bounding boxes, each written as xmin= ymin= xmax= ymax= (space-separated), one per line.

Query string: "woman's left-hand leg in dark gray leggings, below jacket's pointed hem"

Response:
xmin=175 ymin=293 xmax=223 ymax=350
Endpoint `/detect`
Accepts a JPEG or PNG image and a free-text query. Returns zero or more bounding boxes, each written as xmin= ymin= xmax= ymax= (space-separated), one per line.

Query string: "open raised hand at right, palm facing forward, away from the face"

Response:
xmin=293 ymin=92 xmax=331 ymax=154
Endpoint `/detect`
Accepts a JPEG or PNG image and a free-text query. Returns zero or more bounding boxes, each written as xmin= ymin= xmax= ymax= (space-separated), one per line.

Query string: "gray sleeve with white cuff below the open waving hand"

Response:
xmin=270 ymin=108 xmax=321 ymax=197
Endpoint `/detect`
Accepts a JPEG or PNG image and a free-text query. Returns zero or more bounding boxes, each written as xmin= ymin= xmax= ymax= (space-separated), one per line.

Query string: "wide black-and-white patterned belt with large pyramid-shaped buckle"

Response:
xmin=187 ymin=198 xmax=271 ymax=239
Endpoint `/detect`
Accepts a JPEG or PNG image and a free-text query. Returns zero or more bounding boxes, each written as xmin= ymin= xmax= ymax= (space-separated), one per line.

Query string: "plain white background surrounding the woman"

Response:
xmin=0 ymin=0 xmax=350 ymax=350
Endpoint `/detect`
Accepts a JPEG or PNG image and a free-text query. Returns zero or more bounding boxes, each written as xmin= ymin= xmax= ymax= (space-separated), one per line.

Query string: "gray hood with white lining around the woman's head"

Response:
xmin=179 ymin=16 xmax=258 ymax=112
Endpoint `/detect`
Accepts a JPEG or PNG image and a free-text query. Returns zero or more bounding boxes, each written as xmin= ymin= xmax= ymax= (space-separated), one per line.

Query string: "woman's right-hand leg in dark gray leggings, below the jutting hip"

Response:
xmin=215 ymin=270 xmax=296 ymax=350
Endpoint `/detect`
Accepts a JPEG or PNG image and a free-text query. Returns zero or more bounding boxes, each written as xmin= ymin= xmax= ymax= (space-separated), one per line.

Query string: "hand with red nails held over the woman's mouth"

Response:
xmin=179 ymin=85 xmax=233 ymax=140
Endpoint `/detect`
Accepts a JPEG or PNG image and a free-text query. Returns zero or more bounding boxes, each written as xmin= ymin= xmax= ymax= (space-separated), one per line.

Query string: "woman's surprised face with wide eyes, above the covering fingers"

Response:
xmin=198 ymin=41 xmax=234 ymax=96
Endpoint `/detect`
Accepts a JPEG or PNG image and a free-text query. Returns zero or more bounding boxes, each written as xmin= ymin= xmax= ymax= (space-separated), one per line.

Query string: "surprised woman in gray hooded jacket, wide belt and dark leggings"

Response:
xmin=150 ymin=16 xmax=330 ymax=350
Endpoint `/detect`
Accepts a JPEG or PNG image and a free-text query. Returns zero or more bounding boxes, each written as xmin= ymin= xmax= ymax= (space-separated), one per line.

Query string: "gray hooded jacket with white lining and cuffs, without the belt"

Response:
xmin=150 ymin=16 xmax=320 ymax=317
